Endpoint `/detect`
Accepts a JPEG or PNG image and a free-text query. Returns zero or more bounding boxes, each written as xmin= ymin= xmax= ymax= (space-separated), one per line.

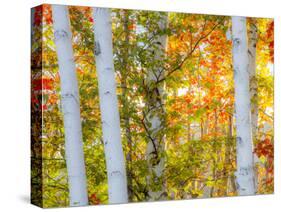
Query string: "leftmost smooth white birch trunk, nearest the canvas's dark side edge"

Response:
xmin=52 ymin=5 xmax=88 ymax=206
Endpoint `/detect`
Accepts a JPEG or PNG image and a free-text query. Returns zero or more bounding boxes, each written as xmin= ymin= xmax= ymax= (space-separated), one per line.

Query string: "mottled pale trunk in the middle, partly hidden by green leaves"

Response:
xmin=145 ymin=14 xmax=168 ymax=201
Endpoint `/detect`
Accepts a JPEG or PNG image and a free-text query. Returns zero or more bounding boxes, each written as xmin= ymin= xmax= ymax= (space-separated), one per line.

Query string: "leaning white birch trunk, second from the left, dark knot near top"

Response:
xmin=93 ymin=8 xmax=128 ymax=203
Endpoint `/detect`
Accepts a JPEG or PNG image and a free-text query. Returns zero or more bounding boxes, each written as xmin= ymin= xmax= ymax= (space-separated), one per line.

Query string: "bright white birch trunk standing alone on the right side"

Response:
xmin=232 ymin=17 xmax=255 ymax=195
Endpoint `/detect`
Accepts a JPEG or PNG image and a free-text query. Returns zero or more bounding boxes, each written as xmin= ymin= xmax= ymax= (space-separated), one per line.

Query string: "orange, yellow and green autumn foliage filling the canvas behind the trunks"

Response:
xmin=31 ymin=5 xmax=274 ymax=207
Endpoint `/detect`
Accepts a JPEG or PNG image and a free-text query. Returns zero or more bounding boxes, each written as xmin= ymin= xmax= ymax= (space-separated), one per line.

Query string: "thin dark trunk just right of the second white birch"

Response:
xmin=121 ymin=10 xmax=133 ymax=202
